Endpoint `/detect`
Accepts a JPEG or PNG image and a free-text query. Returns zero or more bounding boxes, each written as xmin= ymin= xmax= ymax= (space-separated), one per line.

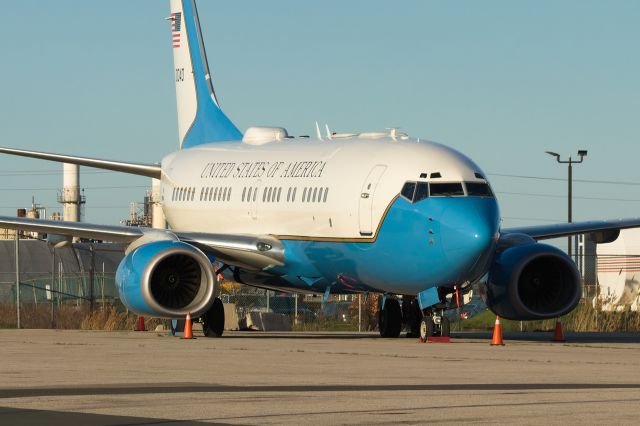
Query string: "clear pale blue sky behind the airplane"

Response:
xmin=0 ymin=0 xmax=640 ymax=236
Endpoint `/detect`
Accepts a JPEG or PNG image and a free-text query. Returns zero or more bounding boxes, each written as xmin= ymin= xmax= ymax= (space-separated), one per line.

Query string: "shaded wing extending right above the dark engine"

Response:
xmin=500 ymin=218 xmax=640 ymax=241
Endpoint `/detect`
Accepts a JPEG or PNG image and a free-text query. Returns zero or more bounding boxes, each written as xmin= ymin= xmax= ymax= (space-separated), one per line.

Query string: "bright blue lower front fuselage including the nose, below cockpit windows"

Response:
xmin=228 ymin=197 xmax=500 ymax=295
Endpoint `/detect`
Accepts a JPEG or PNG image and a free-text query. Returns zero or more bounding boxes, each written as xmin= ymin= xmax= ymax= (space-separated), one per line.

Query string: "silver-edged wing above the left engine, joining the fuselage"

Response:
xmin=0 ymin=216 xmax=284 ymax=270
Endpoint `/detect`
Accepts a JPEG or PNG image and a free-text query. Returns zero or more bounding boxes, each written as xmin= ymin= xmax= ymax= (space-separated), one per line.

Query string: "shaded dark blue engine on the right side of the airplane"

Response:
xmin=484 ymin=243 xmax=582 ymax=320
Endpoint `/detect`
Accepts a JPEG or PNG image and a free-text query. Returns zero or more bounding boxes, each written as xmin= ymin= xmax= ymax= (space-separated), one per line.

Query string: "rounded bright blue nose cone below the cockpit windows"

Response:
xmin=440 ymin=199 xmax=499 ymax=268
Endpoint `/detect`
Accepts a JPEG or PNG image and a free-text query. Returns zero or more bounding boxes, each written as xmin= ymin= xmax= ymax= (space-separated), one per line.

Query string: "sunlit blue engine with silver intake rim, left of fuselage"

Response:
xmin=116 ymin=241 xmax=218 ymax=318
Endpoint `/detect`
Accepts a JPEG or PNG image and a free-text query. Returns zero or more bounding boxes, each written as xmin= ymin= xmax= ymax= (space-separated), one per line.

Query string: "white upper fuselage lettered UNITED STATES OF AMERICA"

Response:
xmin=162 ymin=137 xmax=480 ymax=239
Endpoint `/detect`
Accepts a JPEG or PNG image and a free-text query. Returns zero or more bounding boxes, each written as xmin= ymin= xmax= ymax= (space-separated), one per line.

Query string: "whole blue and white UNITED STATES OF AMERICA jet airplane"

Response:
xmin=0 ymin=0 xmax=640 ymax=339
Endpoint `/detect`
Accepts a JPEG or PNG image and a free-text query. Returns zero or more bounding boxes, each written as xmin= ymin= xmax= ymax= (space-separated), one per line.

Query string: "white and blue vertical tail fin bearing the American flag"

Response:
xmin=167 ymin=0 xmax=242 ymax=148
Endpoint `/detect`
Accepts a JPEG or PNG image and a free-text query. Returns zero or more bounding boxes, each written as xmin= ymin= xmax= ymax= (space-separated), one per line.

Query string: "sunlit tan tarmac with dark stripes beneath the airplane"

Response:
xmin=0 ymin=330 xmax=640 ymax=425
